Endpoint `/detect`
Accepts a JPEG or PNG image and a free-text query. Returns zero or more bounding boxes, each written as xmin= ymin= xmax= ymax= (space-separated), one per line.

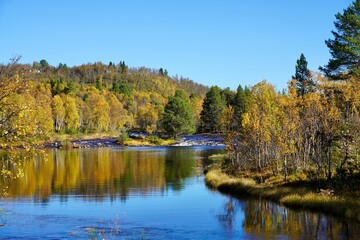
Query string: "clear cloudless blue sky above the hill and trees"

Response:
xmin=0 ymin=0 xmax=352 ymax=90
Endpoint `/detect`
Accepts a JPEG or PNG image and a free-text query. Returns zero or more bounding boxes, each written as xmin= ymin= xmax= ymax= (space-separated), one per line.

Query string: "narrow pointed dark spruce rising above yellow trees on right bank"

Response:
xmin=292 ymin=54 xmax=315 ymax=96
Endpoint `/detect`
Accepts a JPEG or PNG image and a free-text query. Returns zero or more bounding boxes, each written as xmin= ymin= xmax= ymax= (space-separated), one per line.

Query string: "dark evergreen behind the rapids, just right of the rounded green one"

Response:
xmin=200 ymin=86 xmax=225 ymax=133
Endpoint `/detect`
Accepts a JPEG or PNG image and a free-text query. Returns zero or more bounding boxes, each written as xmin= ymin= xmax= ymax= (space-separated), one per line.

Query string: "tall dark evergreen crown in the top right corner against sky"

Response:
xmin=320 ymin=0 xmax=360 ymax=79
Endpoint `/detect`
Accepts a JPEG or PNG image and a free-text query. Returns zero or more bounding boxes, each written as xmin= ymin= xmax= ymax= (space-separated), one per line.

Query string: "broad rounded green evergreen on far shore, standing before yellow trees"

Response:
xmin=162 ymin=90 xmax=195 ymax=137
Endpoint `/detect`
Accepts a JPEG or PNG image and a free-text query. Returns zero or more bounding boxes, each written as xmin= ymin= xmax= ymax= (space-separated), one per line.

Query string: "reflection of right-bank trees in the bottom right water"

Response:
xmin=216 ymin=197 xmax=360 ymax=239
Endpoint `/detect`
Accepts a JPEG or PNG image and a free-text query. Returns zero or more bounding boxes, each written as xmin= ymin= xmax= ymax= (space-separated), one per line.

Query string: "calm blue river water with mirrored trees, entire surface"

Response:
xmin=0 ymin=147 xmax=360 ymax=239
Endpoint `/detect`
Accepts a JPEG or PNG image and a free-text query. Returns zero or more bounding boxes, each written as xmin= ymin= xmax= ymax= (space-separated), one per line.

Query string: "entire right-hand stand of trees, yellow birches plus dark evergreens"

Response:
xmin=200 ymin=0 xmax=360 ymax=184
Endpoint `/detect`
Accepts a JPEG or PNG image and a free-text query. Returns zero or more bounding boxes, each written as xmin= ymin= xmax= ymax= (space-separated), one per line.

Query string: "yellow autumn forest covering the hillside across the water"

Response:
xmin=0 ymin=59 xmax=208 ymax=145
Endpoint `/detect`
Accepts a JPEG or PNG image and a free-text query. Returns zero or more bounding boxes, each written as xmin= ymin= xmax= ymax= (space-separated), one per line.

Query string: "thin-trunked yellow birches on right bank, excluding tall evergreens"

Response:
xmin=224 ymin=78 xmax=360 ymax=179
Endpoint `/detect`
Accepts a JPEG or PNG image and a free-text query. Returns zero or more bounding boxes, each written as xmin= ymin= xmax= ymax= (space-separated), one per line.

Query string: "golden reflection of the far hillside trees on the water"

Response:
xmin=0 ymin=148 xmax=208 ymax=202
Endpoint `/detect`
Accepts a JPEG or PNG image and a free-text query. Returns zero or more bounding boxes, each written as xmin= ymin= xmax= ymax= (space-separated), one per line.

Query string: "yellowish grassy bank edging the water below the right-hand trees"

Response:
xmin=205 ymin=170 xmax=360 ymax=221
